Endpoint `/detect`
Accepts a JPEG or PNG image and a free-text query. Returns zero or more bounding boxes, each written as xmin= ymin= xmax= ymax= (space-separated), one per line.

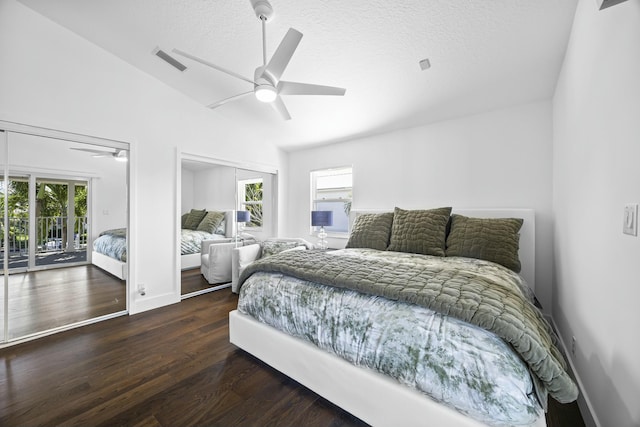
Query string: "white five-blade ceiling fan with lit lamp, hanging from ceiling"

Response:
xmin=173 ymin=0 xmax=346 ymax=120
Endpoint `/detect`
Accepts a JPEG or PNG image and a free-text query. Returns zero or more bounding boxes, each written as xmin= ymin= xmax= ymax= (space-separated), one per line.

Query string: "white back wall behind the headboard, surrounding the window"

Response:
xmin=286 ymin=102 xmax=553 ymax=312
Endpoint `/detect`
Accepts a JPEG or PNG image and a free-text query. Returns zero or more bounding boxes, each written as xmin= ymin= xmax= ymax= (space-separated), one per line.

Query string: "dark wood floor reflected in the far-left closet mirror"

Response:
xmin=0 ymin=264 xmax=127 ymax=339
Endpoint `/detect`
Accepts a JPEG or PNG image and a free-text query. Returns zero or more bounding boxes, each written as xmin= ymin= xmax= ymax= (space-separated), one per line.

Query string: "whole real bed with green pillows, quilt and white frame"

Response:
xmin=229 ymin=208 xmax=577 ymax=427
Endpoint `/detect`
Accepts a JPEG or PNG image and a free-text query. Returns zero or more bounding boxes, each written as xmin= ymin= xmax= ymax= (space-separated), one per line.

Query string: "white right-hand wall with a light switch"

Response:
xmin=553 ymin=0 xmax=640 ymax=427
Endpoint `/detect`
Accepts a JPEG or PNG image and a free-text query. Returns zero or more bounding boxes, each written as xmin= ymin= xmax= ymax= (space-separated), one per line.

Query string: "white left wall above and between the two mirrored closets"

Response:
xmin=0 ymin=0 xmax=285 ymax=313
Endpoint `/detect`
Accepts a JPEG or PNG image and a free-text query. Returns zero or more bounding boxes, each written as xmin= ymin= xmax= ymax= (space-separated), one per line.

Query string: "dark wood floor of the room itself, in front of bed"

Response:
xmin=0 ymin=289 xmax=583 ymax=427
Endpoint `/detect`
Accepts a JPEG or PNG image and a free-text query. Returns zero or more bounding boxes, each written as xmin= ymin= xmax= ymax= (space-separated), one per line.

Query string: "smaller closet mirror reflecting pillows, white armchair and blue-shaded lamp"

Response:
xmin=180 ymin=159 xmax=276 ymax=298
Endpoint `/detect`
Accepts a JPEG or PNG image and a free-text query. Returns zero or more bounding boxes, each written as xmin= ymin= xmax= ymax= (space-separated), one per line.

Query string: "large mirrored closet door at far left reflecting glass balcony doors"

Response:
xmin=0 ymin=122 xmax=129 ymax=343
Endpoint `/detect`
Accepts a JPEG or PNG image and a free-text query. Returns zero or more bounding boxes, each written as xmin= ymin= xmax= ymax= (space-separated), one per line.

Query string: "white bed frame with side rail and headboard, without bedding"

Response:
xmin=229 ymin=209 xmax=546 ymax=427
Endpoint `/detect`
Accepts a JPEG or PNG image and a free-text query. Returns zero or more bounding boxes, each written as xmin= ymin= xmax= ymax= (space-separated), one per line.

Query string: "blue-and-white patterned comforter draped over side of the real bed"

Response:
xmin=238 ymin=251 xmax=543 ymax=426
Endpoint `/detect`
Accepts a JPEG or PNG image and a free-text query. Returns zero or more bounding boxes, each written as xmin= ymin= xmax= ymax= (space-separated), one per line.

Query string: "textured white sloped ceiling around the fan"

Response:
xmin=21 ymin=0 xmax=577 ymax=149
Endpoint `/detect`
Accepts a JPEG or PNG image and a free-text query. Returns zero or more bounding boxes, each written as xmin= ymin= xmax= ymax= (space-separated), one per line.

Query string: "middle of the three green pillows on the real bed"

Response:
xmin=387 ymin=207 xmax=451 ymax=256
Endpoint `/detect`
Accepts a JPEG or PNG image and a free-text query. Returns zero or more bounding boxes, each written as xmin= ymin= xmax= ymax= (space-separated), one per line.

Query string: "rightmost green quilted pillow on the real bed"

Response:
xmin=447 ymin=214 xmax=523 ymax=273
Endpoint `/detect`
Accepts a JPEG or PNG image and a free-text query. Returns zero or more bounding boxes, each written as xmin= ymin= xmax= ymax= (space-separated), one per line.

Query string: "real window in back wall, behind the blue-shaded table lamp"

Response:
xmin=309 ymin=166 xmax=353 ymax=235
